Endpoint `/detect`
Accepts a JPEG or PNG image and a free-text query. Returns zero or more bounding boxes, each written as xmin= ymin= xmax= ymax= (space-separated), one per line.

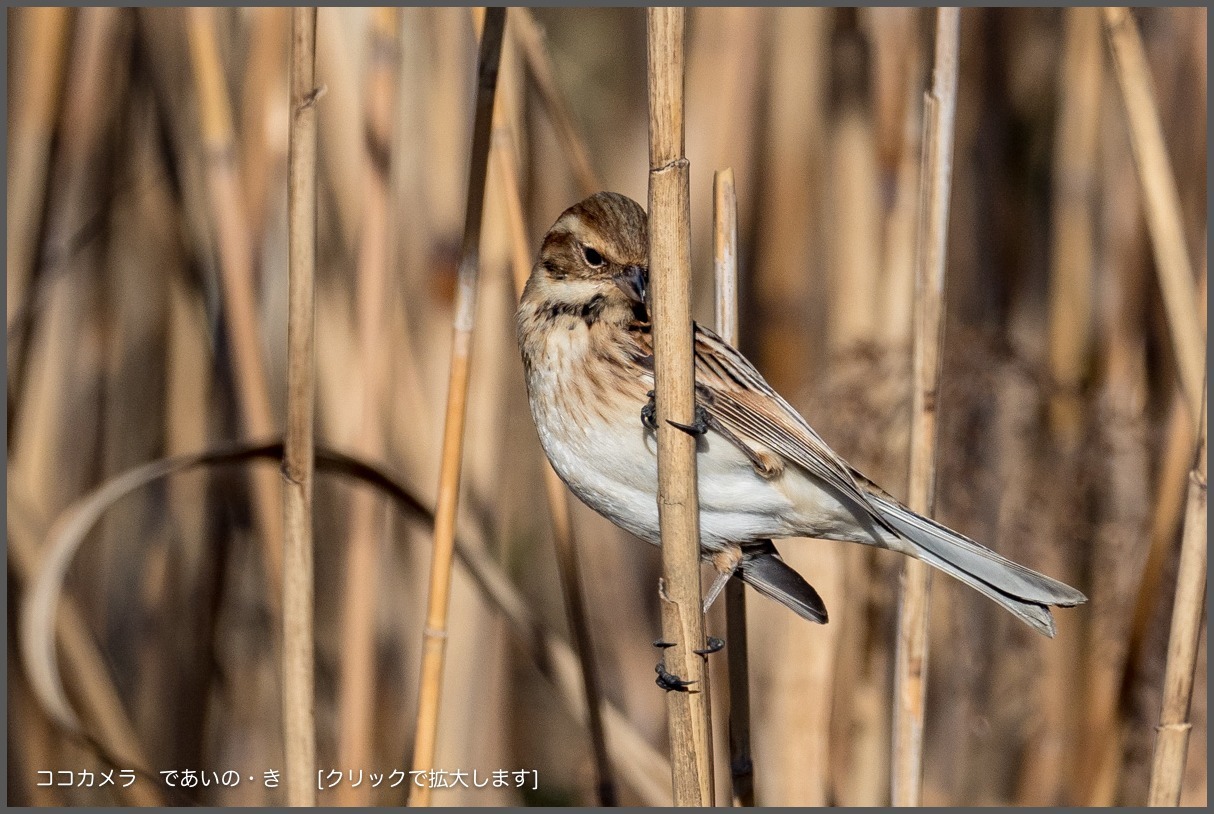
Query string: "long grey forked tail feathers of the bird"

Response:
xmin=869 ymin=495 xmax=1088 ymax=637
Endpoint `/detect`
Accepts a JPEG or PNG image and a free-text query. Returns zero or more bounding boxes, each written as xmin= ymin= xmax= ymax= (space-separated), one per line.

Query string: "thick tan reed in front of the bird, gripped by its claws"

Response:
xmin=647 ymin=8 xmax=714 ymax=806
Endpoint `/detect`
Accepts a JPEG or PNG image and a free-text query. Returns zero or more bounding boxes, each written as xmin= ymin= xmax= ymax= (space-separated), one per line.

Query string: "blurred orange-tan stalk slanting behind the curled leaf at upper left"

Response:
xmin=187 ymin=8 xmax=283 ymax=604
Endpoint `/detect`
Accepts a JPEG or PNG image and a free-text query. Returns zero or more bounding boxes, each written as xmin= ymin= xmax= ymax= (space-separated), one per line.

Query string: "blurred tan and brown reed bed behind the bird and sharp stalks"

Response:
xmin=7 ymin=8 xmax=1207 ymax=806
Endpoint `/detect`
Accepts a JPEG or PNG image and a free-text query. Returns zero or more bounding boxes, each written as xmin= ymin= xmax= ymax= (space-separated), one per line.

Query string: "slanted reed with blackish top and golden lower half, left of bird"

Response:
xmin=409 ymin=7 xmax=506 ymax=806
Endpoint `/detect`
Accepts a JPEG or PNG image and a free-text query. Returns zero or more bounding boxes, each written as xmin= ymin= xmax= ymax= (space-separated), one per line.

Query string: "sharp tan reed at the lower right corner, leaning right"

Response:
xmin=1147 ymin=388 xmax=1208 ymax=806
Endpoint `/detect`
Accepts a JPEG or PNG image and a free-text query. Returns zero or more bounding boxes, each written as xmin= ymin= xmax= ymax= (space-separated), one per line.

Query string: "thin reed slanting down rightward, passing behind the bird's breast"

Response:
xmin=490 ymin=79 xmax=618 ymax=806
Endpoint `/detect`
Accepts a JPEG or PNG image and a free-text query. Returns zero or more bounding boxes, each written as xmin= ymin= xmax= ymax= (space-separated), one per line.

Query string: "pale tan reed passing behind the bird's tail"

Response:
xmin=890 ymin=8 xmax=960 ymax=806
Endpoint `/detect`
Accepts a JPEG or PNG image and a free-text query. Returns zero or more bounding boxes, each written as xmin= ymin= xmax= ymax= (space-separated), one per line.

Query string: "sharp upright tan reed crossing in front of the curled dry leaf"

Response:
xmin=282 ymin=8 xmax=318 ymax=806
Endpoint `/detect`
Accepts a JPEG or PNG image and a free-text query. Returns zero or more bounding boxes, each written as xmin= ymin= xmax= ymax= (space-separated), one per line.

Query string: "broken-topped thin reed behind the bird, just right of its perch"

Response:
xmin=713 ymin=167 xmax=755 ymax=806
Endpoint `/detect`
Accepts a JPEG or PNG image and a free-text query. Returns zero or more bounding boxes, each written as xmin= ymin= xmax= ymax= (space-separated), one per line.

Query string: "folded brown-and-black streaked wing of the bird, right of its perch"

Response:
xmin=696 ymin=325 xmax=872 ymax=511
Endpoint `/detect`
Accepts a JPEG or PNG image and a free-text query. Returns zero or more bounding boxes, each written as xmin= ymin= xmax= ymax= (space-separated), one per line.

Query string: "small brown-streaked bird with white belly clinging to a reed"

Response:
xmin=517 ymin=192 xmax=1087 ymax=636
